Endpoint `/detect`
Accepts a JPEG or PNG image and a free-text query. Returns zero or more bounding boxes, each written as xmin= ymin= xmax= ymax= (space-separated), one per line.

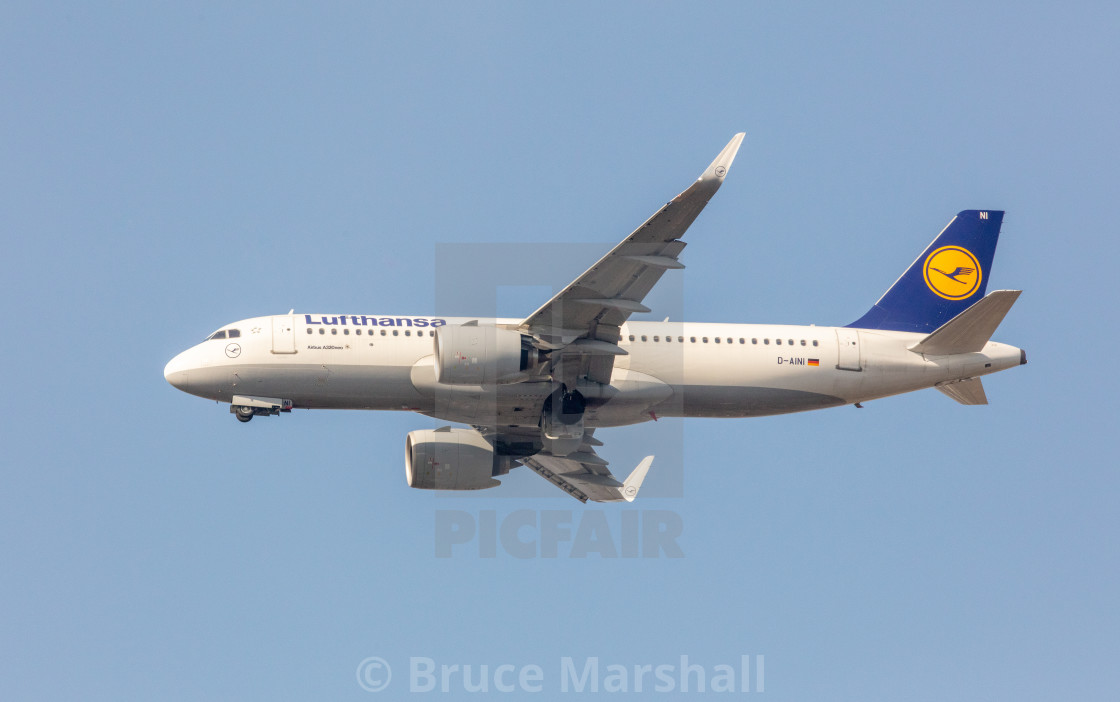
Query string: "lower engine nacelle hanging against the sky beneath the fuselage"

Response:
xmin=404 ymin=429 xmax=512 ymax=490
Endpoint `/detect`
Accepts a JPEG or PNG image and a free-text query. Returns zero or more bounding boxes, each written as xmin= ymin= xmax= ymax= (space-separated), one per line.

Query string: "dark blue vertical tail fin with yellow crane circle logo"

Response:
xmin=848 ymin=209 xmax=1004 ymax=334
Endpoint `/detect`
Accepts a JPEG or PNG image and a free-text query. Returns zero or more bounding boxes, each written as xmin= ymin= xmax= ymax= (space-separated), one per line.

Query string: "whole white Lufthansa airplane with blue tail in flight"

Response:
xmin=164 ymin=133 xmax=1027 ymax=503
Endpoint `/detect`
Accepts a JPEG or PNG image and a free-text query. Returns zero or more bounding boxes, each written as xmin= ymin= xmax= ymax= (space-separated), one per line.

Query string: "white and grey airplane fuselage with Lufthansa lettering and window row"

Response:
xmin=165 ymin=315 xmax=1021 ymax=427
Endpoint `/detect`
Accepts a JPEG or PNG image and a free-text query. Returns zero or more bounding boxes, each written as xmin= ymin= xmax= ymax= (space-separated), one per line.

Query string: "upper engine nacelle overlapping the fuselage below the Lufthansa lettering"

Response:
xmin=436 ymin=325 xmax=542 ymax=385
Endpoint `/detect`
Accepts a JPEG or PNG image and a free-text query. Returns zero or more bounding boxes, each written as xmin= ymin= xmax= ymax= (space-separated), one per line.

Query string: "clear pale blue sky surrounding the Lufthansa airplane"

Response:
xmin=0 ymin=2 xmax=1120 ymax=700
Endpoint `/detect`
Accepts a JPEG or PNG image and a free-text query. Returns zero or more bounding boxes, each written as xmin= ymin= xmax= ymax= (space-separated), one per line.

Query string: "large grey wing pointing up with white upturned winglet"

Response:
xmin=520 ymin=133 xmax=744 ymax=383
